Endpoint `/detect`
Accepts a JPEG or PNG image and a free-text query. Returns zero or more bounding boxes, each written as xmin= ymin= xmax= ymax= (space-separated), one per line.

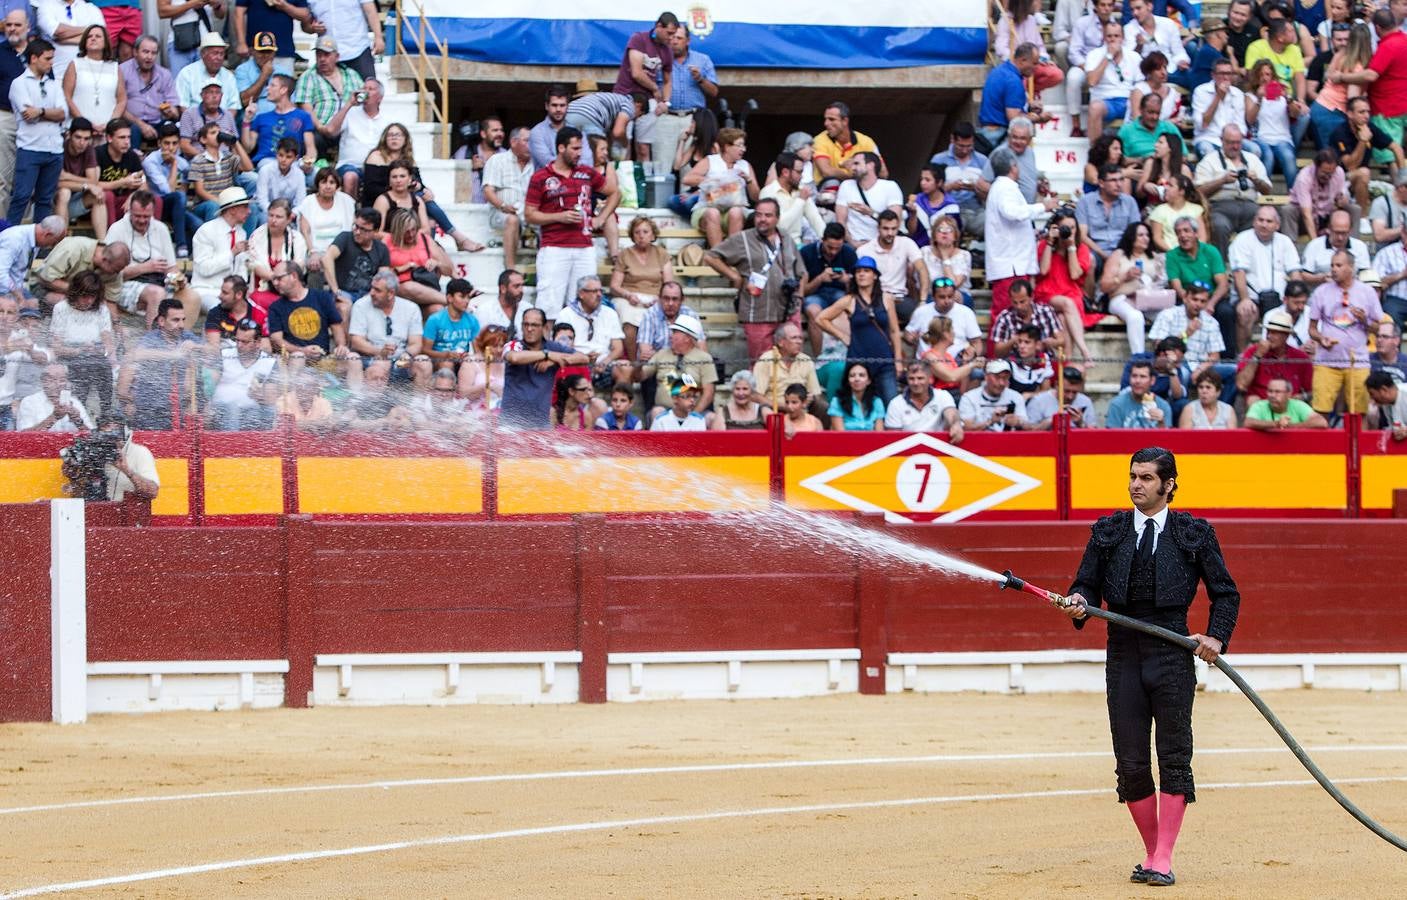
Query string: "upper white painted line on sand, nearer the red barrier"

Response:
xmin=0 ymin=744 xmax=1407 ymax=816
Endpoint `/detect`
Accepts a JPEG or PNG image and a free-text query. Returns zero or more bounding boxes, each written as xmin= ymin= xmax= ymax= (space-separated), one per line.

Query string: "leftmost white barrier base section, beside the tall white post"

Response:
xmin=87 ymin=660 xmax=288 ymax=713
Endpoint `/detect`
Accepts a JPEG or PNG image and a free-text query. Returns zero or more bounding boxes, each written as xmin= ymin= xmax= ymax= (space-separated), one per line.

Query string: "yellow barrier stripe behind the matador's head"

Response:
xmin=1069 ymin=453 xmax=1348 ymax=509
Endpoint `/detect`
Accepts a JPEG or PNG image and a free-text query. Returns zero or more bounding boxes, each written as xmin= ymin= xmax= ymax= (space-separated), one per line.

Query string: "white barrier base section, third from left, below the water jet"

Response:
xmin=606 ymin=648 xmax=860 ymax=702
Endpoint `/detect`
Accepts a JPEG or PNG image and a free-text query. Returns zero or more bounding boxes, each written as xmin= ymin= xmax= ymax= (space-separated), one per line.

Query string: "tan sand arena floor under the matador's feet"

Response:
xmin=0 ymin=690 xmax=1407 ymax=900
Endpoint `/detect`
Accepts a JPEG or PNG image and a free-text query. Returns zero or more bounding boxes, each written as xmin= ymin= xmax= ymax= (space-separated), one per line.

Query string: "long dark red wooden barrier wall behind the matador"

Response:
xmin=0 ymin=503 xmax=1407 ymax=720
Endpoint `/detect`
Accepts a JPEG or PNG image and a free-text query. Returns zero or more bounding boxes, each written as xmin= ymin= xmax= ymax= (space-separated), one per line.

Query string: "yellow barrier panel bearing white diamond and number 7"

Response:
xmin=787 ymin=454 xmax=1055 ymax=513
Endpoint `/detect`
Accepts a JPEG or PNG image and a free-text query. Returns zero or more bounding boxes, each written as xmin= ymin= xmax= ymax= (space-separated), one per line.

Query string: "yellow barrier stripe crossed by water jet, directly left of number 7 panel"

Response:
xmin=498 ymin=456 xmax=768 ymax=516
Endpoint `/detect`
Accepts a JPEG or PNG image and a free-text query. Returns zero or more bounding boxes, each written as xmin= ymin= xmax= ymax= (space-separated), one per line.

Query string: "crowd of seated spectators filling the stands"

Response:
xmin=0 ymin=0 xmax=1407 ymax=442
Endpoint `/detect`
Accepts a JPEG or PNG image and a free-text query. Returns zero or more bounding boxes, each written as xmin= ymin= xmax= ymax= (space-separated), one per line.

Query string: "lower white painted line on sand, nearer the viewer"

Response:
xmin=0 ymin=776 xmax=1407 ymax=900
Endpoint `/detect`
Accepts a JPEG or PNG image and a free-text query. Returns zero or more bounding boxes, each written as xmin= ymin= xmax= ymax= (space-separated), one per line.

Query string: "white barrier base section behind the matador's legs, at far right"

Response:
xmin=885 ymin=650 xmax=1407 ymax=693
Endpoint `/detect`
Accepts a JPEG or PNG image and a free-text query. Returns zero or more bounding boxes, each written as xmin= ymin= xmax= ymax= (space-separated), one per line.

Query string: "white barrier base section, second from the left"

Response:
xmin=311 ymin=651 xmax=581 ymax=706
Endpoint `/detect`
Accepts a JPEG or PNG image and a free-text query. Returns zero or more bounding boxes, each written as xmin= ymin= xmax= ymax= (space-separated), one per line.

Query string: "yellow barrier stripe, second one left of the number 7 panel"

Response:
xmin=296 ymin=457 xmax=484 ymax=515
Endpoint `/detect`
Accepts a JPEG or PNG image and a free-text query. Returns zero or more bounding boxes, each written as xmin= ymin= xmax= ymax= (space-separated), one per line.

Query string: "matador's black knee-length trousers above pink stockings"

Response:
xmin=1104 ymin=608 xmax=1197 ymax=803
